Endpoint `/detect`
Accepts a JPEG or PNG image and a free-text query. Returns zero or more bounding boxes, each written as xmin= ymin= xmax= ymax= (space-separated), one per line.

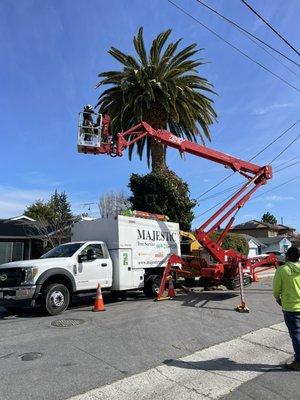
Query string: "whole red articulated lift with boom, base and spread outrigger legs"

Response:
xmin=78 ymin=115 xmax=277 ymax=312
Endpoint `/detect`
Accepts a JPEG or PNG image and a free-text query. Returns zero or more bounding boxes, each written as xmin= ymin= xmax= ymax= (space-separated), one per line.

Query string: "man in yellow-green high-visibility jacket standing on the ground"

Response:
xmin=273 ymin=246 xmax=300 ymax=371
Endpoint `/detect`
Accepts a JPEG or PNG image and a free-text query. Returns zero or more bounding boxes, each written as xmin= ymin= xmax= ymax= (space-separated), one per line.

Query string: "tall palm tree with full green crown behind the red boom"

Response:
xmin=96 ymin=28 xmax=216 ymax=171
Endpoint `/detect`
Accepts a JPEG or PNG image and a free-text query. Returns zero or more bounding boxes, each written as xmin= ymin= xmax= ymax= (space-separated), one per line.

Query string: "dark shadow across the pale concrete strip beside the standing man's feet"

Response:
xmin=164 ymin=357 xmax=287 ymax=372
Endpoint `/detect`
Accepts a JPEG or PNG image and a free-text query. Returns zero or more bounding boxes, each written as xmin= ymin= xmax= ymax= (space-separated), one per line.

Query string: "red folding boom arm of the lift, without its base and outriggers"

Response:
xmin=81 ymin=118 xmax=272 ymax=266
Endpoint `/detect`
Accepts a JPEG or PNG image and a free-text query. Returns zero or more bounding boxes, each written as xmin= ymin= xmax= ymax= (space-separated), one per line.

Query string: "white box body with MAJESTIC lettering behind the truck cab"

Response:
xmin=71 ymin=215 xmax=180 ymax=294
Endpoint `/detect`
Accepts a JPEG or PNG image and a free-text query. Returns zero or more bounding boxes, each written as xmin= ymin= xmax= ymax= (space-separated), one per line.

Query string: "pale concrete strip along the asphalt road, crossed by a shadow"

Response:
xmin=69 ymin=323 xmax=292 ymax=400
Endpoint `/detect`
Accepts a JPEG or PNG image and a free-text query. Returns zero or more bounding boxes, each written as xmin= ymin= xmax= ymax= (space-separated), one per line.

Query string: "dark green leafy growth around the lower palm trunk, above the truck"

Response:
xmin=129 ymin=170 xmax=196 ymax=230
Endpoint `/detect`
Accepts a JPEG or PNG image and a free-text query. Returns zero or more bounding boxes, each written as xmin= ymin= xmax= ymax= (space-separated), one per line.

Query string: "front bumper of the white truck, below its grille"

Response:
xmin=0 ymin=286 xmax=37 ymax=307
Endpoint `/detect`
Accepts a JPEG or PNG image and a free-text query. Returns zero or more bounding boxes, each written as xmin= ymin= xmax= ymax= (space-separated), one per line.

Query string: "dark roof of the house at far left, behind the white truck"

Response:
xmin=0 ymin=219 xmax=43 ymax=238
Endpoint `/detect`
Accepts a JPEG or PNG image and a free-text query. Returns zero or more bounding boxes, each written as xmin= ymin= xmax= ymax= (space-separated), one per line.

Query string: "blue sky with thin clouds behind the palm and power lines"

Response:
xmin=0 ymin=0 xmax=300 ymax=229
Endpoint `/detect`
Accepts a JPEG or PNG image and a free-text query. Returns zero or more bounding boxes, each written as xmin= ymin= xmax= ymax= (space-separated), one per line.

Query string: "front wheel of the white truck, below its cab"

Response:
xmin=42 ymin=283 xmax=70 ymax=315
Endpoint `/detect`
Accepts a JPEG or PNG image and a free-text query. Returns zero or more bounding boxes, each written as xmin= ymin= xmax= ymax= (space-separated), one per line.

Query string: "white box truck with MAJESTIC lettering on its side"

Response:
xmin=0 ymin=216 xmax=180 ymax=315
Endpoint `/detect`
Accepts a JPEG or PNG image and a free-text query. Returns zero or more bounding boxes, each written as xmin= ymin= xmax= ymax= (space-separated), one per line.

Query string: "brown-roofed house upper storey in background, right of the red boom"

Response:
xmin=230 ymin=220 xmax=295 ymax=238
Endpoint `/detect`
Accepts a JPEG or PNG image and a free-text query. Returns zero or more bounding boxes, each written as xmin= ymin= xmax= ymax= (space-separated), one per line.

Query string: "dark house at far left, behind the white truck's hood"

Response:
xmin=0 ymin=216 xmax=43 ymax=264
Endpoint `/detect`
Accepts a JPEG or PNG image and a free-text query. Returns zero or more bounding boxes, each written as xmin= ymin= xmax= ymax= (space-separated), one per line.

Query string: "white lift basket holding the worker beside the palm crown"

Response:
xmin=77 ymin=112 xmax=102 ymax=153
